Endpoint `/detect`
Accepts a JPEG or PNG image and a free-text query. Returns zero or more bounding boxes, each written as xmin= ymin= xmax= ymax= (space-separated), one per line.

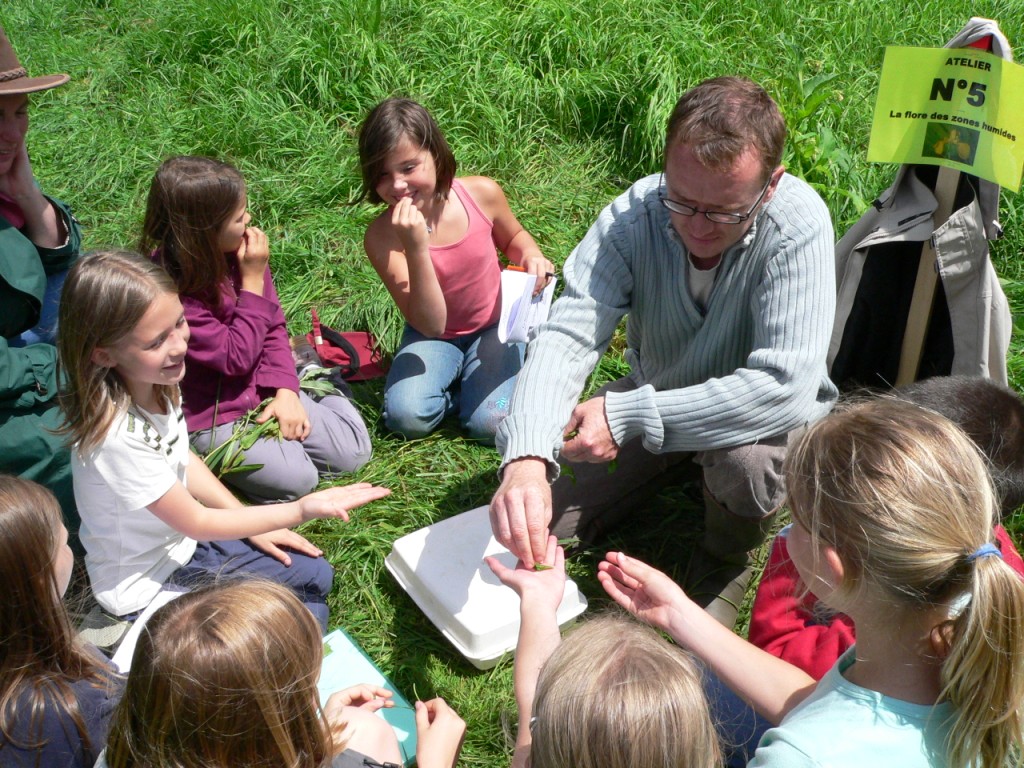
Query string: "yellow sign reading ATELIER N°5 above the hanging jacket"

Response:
xmin=867 ymin=47 xmax=1024 ymax=190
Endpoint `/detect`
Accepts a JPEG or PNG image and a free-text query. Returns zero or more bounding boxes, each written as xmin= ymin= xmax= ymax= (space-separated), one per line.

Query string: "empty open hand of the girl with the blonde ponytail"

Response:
xmin=597 ymin=552 xmax=690 ymax=631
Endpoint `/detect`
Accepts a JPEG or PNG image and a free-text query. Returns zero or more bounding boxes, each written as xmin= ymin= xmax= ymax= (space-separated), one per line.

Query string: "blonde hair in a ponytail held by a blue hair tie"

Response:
xmin=783 ymin=398 xmax=1024 ymax=766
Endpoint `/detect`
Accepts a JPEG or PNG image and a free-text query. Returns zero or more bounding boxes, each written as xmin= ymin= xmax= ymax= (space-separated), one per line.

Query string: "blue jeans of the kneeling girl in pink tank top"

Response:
xmin=384 ymin=325 xmax=525 ymax=444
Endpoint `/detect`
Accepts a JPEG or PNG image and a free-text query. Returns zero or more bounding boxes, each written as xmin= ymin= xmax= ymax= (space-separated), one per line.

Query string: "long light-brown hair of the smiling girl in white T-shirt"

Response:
xmin=57 ymin=251 xmax=178 ymax=455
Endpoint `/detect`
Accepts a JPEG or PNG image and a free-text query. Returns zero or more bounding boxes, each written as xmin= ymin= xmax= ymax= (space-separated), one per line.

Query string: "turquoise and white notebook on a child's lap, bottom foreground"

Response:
xmin=316 ymin=629 xmax=416 ymax=766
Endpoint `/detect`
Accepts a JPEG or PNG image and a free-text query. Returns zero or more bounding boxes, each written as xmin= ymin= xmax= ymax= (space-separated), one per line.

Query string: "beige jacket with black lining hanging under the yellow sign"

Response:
xmin=828 ymin=18 xmax=1012 ymax=390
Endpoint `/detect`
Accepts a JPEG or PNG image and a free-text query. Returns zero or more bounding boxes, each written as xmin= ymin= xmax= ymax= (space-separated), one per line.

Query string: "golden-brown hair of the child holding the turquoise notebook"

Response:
xmin=106 ymin=579 xmax=333 ymax=768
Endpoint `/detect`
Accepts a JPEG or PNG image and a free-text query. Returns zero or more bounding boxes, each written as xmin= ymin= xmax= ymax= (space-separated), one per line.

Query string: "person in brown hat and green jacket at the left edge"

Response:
xmin=0 ymin=29 xmax=81 ymax=548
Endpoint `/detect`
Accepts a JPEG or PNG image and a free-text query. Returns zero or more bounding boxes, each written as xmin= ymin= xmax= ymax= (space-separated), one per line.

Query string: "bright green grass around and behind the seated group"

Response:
xmin=8 ymin=0 xmax=1024 ymax=766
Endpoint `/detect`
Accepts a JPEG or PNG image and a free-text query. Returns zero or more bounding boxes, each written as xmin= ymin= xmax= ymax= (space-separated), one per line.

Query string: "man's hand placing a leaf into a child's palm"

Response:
xmin=490 ymin=457 xmax=551 ymax=568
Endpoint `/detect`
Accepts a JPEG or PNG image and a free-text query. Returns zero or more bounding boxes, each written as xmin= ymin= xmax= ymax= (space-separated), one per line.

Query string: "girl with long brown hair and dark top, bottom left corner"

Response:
xmin=0 ymin=475 xmax=123 ymax=768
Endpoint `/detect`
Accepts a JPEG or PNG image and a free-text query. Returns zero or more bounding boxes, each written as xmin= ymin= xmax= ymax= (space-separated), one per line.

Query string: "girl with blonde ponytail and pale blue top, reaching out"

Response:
xmin=599 ymin=399 xmax=1024 ymax=768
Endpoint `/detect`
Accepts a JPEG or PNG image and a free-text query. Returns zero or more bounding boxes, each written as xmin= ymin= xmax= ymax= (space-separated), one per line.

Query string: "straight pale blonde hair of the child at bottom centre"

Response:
xmin=529 ymin=614 xmax=721 ymax=768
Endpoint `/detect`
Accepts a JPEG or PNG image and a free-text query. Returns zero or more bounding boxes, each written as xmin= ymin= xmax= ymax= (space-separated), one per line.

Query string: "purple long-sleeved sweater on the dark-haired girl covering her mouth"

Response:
xmin=174 ymin=258 xmax=299 ymax=432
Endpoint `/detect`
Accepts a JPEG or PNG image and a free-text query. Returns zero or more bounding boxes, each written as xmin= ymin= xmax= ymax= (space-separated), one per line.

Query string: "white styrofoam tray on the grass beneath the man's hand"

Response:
xmin=384 ymin=507 xmax=587 ymax=670
